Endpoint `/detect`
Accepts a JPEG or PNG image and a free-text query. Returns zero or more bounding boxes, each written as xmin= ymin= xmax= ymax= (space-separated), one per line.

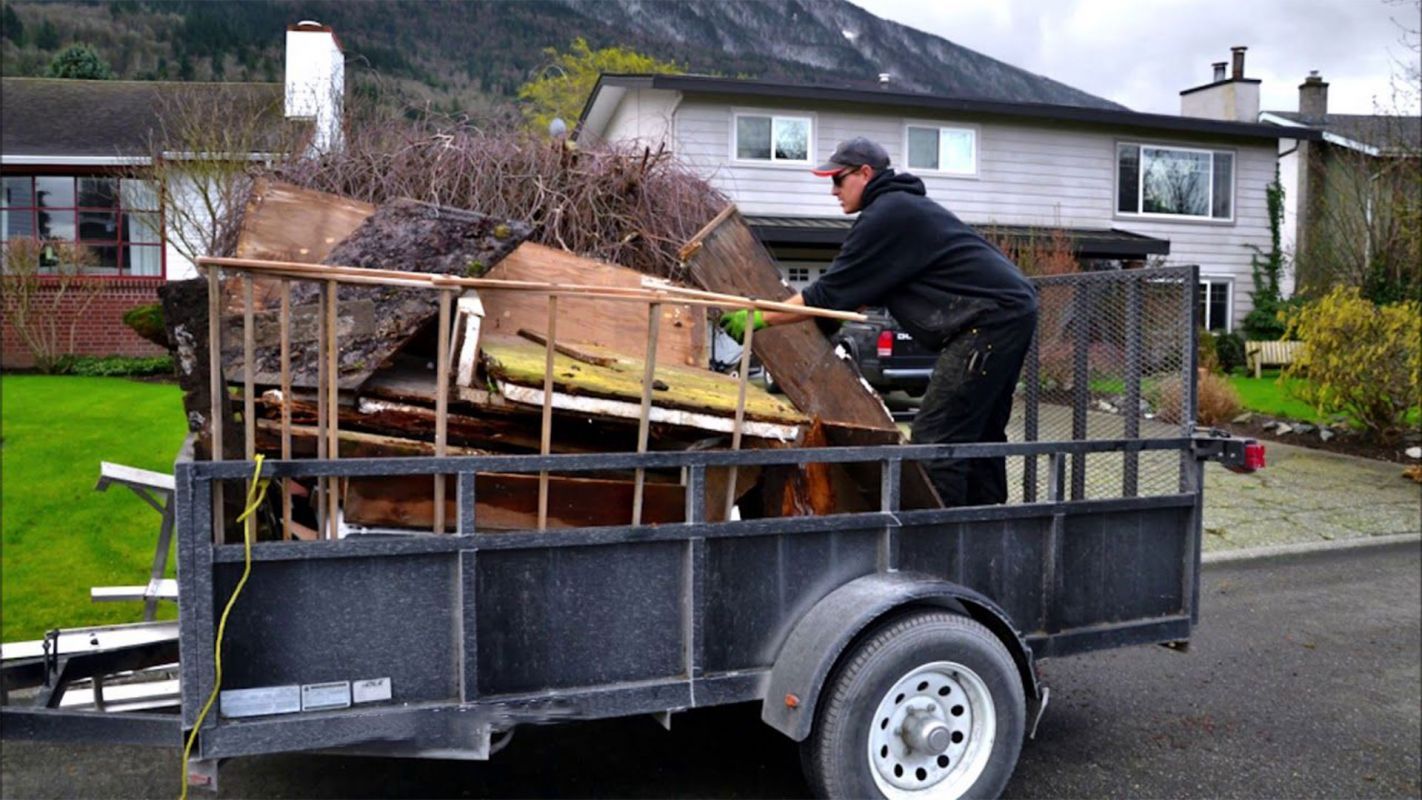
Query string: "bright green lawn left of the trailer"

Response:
xmin=0 ymin=375 xmax=185 ymax=641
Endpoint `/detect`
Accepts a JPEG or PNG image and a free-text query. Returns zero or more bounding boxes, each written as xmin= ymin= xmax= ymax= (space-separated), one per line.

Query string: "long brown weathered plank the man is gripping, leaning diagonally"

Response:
xmin=681 ymin=206 xmax=943 ymax=509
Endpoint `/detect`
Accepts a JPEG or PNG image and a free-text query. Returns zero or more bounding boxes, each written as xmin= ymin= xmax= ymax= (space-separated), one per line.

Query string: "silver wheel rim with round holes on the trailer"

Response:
xmin=867 ymin=661 xmax=997 ymax=800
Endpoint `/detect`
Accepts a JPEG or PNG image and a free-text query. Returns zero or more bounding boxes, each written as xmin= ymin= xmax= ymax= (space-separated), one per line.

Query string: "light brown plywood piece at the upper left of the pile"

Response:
xmin=223 ymin=178 xmax=375 ymax=313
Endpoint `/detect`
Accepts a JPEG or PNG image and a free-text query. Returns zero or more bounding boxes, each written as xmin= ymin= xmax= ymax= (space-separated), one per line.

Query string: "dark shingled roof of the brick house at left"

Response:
xmin=0 ymin=78 xmax=284 ymax=162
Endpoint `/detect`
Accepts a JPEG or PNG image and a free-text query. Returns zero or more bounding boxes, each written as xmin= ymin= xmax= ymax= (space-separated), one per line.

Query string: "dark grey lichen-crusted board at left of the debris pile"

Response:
xmin=223 ymin=200 xmax=532 ymax=389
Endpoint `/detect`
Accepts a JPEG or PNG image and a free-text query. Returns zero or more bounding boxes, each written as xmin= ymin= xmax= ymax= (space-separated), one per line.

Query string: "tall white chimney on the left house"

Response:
xmin=286 ymin=20 xmax=346 ymax=153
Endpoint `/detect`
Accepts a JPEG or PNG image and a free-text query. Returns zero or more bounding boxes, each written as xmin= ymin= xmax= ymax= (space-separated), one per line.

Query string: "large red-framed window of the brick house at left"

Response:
xmin=0 ymin=175 xmax=164 ymax=277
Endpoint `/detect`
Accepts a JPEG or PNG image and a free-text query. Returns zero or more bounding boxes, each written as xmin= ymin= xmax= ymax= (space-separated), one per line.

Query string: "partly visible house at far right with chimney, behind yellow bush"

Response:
xmin=1258 ymin=71 xmax=1422 ymax=295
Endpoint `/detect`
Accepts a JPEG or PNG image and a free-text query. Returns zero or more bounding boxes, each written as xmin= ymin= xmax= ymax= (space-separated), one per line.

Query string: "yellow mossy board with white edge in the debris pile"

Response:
xmin=483 ymin=337 xmax=809 ymax=436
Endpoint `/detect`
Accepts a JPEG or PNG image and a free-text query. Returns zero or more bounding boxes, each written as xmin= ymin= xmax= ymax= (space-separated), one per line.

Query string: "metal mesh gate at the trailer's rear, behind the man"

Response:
xmin=1008 ymin=266 xmax=1197 ymax=502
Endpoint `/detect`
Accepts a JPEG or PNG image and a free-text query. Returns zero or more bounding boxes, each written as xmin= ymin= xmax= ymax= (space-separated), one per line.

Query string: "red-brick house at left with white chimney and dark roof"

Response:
xmin=0 ymin=23 xmax=344 ymax=368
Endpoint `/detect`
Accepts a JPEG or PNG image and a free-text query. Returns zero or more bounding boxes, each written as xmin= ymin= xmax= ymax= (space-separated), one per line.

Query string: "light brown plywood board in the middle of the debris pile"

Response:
xmin=479 ymin=242 xmax=707 ymax=367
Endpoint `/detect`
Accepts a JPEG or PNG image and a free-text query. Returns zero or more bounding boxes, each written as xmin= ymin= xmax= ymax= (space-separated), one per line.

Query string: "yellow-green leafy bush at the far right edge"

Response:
xmin=1284 ymin=287 xmax=1422 ymax=440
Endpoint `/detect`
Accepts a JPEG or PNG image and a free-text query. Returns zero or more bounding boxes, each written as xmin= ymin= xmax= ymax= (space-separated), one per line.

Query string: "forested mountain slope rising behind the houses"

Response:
xmin=0 ymin=0 xmax=1122 ymax=115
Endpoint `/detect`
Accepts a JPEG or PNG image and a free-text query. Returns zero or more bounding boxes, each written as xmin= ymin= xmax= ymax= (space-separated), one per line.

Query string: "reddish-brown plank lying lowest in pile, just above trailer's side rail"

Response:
xmin=346 ymin=473 xmax=685 ymax=531
